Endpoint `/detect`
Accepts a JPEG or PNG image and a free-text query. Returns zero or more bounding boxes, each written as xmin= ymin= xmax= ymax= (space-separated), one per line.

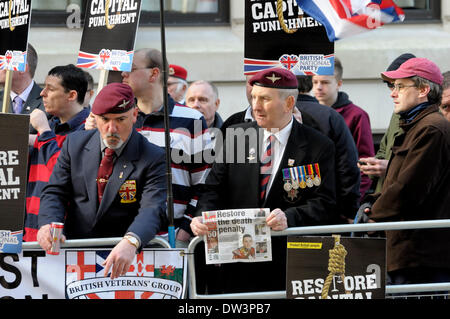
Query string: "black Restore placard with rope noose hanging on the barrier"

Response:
xmin=286 ymin=235 xmax=386 ymax=299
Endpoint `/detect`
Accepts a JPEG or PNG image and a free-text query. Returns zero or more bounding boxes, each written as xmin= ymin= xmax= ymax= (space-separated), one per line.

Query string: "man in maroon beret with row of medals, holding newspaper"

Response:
xmin=191 ymin=68 xmax=338 ymax=293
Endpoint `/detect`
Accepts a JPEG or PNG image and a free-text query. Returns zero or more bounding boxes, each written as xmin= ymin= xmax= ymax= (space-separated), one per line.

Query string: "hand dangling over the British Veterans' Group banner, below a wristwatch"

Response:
xmin=102 ymin=239 xmax=136 ymax=279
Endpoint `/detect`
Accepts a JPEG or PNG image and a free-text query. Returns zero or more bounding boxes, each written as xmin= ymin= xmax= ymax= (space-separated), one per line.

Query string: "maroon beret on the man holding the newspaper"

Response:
xmin=249 ymin=68 xmax=298 ymax=89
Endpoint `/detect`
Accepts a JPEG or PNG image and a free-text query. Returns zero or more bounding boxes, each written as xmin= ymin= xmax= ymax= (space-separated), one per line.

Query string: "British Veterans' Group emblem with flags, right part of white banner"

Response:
xmin=65 ymin=249 xmax=187 ymax=299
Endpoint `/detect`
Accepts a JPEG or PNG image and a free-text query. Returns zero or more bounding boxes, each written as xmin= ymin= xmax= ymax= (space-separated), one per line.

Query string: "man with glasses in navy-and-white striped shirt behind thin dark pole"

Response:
xmin=122 ymin=48 xmax=212 ymax=247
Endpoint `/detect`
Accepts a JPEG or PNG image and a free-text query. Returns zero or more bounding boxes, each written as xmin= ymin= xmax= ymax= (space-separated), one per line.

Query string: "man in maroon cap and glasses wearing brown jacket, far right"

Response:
xmin=367 ymin=58 xmax=450 ymax=284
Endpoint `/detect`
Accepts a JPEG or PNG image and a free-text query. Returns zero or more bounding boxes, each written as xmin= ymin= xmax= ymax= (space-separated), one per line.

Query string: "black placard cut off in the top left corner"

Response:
xmin=0 ymin=0 xmax=31 ymax=72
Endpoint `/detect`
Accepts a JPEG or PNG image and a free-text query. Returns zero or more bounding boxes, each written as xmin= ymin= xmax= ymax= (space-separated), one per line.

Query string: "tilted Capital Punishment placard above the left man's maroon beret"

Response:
xmin=77 ymin=0 xmax=141 ymax=71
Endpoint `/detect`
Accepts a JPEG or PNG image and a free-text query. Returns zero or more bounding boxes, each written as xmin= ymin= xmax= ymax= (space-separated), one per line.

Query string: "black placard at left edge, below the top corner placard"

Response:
xmin=0 ymin=114 xmax=29 ymax=253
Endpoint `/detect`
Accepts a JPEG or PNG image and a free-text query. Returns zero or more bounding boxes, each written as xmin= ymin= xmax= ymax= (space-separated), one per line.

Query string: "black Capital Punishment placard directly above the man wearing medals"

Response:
xmin=244 ymin=0 xmax=334 ymax=75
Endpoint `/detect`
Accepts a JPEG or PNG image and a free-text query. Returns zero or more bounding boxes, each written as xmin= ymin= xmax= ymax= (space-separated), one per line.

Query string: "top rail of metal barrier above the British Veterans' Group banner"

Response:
xmin=22 ymin=236 xmax=170 ymax=249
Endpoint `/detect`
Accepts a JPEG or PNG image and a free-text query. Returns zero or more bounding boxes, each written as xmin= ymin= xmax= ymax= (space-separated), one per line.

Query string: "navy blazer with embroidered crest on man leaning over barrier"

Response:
xmin=39 ymin=130 xmax=166 ymax=244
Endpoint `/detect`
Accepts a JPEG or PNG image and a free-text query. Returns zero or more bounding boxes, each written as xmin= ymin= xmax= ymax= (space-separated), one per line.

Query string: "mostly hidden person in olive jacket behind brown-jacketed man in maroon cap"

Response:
xmin=358 ymin=53 xmax=415 ymax=193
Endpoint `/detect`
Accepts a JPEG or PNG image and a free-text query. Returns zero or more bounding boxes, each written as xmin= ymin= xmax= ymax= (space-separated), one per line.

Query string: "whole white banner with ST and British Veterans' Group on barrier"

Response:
xmin=0 ymin=248 xmax=187 ymax=299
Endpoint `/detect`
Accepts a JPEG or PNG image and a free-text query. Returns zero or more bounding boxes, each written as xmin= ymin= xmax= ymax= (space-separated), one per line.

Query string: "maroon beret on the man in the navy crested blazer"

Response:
xmin=92 ymin=82 xmax=135 ymax=115
